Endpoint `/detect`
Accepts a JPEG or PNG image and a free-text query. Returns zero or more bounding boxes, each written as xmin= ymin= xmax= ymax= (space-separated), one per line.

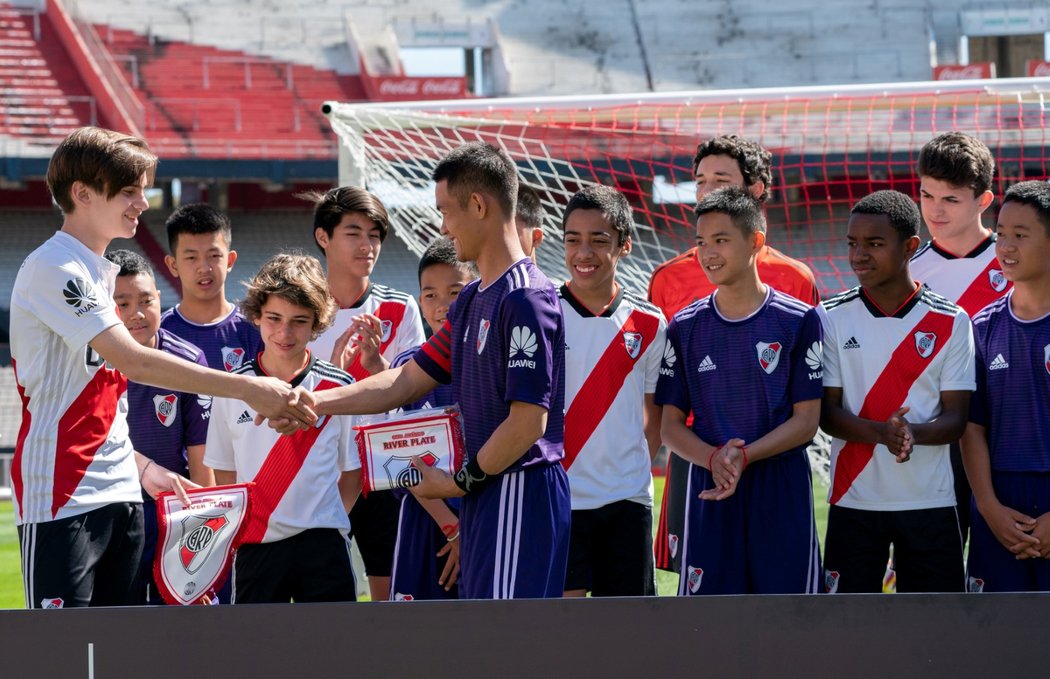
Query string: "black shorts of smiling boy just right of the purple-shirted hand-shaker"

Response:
xmin=565 ymin=500 xmax=656 ymax=596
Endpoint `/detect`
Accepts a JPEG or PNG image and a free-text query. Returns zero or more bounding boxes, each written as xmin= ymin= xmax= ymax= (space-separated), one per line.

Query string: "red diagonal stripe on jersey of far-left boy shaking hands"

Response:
xmin=51 ymin=366 xmax=128 ymax=517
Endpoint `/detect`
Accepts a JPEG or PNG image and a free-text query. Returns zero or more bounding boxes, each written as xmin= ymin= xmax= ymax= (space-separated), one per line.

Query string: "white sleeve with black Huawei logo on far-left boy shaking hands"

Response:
xmin=24 ymin=259 xmax=121 ymax=351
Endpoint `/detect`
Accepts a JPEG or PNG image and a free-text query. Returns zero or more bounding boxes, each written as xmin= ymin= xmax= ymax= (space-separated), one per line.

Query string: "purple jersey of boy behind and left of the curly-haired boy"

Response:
xmin=161 ymin=306 xmax=263 ymax=373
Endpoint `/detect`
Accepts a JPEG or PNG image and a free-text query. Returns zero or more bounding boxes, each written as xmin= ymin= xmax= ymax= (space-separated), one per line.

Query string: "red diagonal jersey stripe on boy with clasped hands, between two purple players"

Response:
xmin=828 ymin=312 xmax=954 ymax=505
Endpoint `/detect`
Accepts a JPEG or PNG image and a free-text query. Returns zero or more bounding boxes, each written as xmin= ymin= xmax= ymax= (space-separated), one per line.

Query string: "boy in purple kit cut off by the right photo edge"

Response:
xmin=963 ymin=182 xmax=1050 ymax=592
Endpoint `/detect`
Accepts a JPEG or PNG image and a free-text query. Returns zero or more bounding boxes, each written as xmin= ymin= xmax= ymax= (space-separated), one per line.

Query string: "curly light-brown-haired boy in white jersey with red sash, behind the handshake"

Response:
xmin=205 ymin=255 xmax=361 ymax=603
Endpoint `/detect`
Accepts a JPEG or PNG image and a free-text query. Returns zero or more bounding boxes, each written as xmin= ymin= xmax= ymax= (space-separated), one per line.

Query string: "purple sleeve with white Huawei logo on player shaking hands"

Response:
xmin=494 ymin=288 xmax=565 ymax=409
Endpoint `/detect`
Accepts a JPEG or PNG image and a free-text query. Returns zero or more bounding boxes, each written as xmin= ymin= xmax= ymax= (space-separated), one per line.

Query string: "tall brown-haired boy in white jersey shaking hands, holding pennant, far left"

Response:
xmin=11 ymin=127 xmax=315 ymax=608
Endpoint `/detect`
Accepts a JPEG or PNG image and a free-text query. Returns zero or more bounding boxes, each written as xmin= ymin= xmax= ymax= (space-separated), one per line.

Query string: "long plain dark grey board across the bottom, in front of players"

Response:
xmin=0 ymin=594 xmax=1050 ymax=679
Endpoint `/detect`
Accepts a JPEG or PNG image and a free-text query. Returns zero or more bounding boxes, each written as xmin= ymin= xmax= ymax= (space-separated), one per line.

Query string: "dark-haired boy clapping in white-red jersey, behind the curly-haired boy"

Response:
xmin=303 ymin=186 xmax=426 ymax=601
